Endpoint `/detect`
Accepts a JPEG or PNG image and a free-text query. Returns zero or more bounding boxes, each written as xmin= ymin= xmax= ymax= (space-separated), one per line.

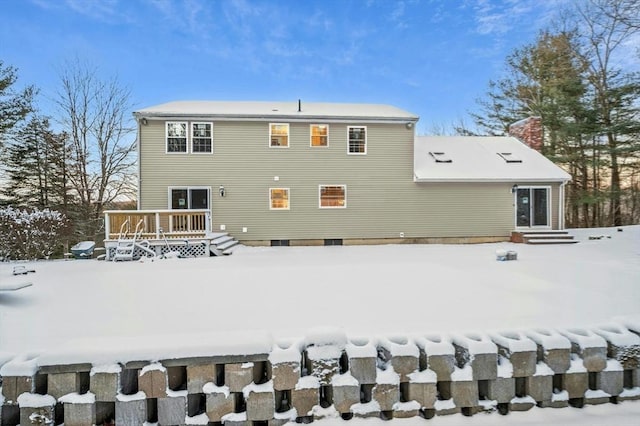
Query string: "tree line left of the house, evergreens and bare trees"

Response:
xmin=0 ymin=60 xmax=135 ymax=253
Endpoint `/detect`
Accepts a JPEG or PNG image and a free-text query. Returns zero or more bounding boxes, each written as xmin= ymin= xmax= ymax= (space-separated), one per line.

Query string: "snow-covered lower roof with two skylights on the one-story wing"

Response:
xmin=413 ymin=136 xmax=571 ymax=182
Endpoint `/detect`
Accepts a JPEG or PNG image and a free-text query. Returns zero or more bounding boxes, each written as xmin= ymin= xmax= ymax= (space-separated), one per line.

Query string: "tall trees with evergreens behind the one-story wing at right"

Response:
xmin=462 ymin=0 xmax=640 ymax=227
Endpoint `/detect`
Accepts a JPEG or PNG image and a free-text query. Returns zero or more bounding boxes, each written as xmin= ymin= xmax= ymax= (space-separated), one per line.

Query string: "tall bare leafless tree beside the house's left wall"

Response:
xmin=55 ymin=60 xmax=135 ymax=237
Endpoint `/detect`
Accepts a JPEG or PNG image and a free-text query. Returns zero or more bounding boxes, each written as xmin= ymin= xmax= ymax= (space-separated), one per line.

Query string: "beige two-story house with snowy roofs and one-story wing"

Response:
xmin=101 ymin=101 xmax=570 ymax=258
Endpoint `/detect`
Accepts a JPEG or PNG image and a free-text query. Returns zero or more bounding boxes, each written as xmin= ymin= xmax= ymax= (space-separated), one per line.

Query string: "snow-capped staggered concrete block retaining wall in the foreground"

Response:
xmin=0 ymin=324 xmax=640 ymax=426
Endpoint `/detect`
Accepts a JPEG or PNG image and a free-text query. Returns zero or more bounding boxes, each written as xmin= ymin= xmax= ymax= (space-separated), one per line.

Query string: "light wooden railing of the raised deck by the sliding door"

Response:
xmin=104 ymin=209 xmax=211 ymax=240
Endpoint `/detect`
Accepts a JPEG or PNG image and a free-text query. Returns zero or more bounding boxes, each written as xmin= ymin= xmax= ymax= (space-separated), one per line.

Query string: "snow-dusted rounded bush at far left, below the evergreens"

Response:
xmin=0 ymin=206 xmax=70 ymax=260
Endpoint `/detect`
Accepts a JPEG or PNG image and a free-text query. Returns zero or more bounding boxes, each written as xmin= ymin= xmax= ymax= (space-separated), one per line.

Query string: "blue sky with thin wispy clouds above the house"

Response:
xmin=0 ymin=0 xmax=571 ymax=133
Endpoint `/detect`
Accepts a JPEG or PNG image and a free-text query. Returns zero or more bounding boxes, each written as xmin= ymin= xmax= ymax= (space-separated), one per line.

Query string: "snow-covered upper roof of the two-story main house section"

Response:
xmin=134 ymin=101 xmax=418 ymax=122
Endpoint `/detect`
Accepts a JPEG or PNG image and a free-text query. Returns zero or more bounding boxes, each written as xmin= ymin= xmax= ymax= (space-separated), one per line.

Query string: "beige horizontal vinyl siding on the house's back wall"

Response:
xmin=140 ymin=120 xmax=557 ymax=241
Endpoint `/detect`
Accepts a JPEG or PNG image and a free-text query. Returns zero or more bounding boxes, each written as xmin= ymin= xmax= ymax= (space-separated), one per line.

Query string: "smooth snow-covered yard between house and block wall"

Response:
xmin=0 ymin=226 xmax=640 ymax=425
